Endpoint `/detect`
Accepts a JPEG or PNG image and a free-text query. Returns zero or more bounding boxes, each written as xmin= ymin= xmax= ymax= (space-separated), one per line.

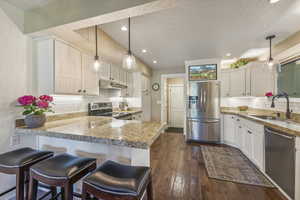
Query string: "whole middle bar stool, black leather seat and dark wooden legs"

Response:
xmin=29 ymin=153 xmax=96 ymax=200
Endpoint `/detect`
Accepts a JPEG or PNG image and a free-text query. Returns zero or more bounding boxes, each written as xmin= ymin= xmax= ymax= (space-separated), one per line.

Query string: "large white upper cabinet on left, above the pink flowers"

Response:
xmin=34 ymin=39 xmax=99 ymax=95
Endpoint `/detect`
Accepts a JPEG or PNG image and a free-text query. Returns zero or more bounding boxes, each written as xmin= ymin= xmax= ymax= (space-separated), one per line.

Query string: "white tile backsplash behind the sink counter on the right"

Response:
xmin=221 ymin=97 xmax=300 ymax=113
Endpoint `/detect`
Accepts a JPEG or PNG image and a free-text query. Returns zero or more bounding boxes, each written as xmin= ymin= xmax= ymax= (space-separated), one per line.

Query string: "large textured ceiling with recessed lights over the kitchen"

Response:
xmin=101 ymin=0 xmax=300 ymax=69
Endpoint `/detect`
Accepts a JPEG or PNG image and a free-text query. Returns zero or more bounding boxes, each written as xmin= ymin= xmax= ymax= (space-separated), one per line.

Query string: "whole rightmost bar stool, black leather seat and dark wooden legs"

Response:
xmin=82 ymin=161 xmax=153 ymax=200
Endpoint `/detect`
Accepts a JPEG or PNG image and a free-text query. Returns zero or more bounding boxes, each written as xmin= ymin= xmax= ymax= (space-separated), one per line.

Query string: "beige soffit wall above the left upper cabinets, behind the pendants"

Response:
xmin=76 ymin=27 xmax=152 ymax=76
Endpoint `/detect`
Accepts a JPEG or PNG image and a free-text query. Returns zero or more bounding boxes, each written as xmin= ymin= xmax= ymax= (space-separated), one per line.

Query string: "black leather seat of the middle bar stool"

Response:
xmin=31 ymin=153 xmax=96 ymax=179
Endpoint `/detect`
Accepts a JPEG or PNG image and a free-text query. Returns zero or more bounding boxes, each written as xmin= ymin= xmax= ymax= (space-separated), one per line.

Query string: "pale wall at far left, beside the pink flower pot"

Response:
xmin=0 ymin=3 xmax=32 ymax=195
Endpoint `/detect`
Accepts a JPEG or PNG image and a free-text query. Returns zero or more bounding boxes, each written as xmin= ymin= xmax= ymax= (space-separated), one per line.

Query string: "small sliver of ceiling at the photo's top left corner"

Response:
xmin=5 ymin=0 xmax=53 ymax=10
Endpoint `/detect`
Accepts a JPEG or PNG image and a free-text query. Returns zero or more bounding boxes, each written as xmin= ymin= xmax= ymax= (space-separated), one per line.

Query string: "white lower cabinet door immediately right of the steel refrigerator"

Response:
xmin=224 ymin=115 xmax=235 ymax=145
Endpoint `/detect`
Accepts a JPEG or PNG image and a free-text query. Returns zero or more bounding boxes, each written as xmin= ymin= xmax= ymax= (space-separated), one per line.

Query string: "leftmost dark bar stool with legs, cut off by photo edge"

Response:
xmin=0 ymin=148 xmax=53 ymax=200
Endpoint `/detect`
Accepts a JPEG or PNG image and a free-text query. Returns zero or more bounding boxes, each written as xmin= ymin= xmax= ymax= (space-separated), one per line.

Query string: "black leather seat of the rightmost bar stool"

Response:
xmin=83 ymin=161 xmax=151 ymax=197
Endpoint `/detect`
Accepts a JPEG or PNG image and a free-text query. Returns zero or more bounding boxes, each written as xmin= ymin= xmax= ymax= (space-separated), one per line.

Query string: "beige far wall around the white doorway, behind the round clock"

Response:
xmin=151 ymin=66 xmax=185 ymax=121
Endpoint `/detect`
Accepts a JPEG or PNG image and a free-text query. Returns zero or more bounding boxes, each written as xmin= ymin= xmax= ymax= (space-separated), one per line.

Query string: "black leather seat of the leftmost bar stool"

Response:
xmin=0 ymin=148 xmax=53 ymax=168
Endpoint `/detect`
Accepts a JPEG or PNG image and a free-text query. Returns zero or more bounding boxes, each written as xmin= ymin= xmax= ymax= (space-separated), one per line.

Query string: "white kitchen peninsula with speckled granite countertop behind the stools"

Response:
xmin=15 ymin=116 xmax=163 ymax=166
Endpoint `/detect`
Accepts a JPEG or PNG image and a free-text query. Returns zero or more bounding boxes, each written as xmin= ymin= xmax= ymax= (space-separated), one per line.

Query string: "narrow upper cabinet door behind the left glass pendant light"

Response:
xmin=82 ymin=54 xmax=99 ymax=96
